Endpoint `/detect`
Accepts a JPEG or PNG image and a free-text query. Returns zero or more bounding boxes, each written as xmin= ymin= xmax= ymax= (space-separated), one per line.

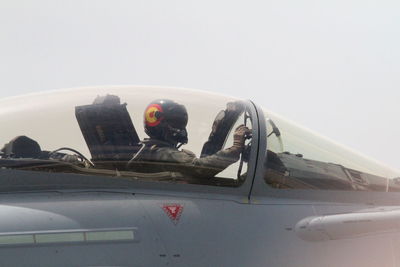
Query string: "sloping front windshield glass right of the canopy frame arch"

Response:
xmin=264 ymin=110 xmax=400 ymax=192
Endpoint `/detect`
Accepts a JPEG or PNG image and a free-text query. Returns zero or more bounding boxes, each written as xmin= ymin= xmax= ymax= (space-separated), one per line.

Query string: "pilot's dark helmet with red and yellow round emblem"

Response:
xmin=144 ymin=99 xmax=188 ymax=146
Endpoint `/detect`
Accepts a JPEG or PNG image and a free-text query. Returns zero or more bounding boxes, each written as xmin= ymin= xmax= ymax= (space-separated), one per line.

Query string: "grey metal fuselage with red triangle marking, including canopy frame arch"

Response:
xmin=0 ymin=87 xmax=400 ymax=267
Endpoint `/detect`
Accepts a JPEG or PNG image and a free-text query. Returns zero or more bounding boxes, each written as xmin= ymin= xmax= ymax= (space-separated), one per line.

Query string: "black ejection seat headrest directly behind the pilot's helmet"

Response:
xmin=75 ymin=95 xmax=140 ymax=161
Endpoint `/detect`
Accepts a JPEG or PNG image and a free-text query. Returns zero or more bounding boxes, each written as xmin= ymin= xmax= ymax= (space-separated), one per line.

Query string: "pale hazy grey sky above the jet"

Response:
xmin=0 ymin=0 xmax=400 ymax=172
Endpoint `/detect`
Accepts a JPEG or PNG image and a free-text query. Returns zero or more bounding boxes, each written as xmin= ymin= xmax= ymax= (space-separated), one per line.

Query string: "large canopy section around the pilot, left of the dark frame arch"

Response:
xmin=0 ymin=87 xmax=254 ymax=186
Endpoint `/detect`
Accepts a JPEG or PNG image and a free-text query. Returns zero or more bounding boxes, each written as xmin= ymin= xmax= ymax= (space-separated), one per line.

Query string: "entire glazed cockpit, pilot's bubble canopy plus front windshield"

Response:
xmin=0 ymin=86 xmax=400 ymax=192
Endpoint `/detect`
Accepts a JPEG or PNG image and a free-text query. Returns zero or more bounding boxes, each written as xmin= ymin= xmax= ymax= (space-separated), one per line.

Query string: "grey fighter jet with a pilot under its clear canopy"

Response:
xmin=0 ymin=86 xmax=400 ymax=267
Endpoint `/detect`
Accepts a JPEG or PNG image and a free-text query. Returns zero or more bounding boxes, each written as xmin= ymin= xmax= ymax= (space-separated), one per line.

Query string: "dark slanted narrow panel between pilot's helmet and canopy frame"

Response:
xmin=200 ymin=101 xmax=245 ymax=157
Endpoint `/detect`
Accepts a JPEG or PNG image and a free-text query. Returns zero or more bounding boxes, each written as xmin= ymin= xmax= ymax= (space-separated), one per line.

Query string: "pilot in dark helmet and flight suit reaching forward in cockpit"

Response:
xmin=128 ymin=99 xmax=251 ymax=177
